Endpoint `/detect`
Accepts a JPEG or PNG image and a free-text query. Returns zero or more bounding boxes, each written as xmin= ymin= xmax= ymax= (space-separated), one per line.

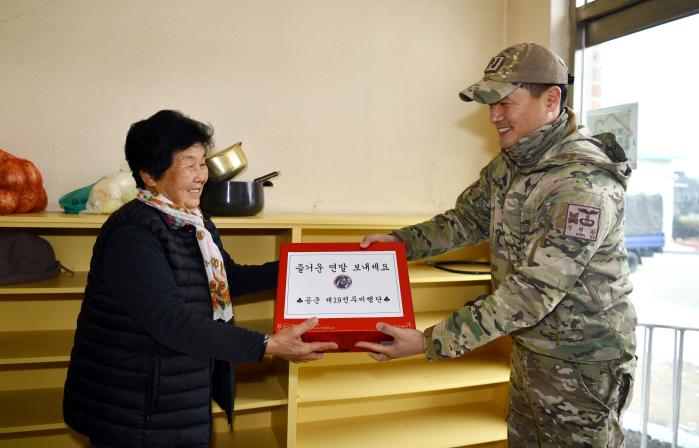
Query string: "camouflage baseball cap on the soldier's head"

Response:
xmin=459 ymin=42 xmax=568 ymax=104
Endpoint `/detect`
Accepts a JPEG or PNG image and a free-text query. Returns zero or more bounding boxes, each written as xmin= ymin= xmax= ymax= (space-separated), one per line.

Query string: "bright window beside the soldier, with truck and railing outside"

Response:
xmin=573 ymin=0 xmax=699 ymax=447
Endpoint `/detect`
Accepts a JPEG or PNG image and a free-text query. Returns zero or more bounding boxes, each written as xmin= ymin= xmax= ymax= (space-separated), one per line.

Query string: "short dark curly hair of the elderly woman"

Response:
xmin=124 ymin=110 xmax=214 ymax=188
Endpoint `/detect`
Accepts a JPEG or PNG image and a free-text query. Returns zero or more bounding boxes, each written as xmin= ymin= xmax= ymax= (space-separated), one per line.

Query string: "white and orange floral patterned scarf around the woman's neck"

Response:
xmin=137 ymin=189 xmax=233 ymax=322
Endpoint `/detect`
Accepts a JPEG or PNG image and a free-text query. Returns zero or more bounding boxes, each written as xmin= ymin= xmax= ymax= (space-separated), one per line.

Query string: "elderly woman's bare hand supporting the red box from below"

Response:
xmin=265 ymin=317 xmax=337 ymax=362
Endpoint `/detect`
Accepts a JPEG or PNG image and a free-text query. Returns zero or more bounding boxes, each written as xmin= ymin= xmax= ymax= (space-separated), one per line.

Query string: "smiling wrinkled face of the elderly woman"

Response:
xmin=144 ymin=143 xmax=209 ymax=211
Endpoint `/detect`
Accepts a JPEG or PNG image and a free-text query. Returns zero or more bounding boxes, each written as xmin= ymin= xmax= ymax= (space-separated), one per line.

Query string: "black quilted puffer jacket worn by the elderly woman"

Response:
xmin=63 ymin=200 xmax=277 ymax=448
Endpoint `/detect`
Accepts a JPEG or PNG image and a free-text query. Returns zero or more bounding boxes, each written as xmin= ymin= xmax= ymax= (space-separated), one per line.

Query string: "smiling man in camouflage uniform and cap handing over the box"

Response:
xmin=357 ymin=43 xmax=636 ymax=447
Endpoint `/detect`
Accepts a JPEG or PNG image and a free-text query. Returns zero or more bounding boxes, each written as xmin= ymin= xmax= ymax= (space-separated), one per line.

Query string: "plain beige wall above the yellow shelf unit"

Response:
xmin=0 ymin=0 xmax=560 ymax=214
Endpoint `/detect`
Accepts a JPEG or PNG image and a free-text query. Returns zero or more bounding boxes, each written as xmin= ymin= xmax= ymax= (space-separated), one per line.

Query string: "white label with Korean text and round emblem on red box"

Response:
xmin=284 ymin=251 xmax=403 ymax=319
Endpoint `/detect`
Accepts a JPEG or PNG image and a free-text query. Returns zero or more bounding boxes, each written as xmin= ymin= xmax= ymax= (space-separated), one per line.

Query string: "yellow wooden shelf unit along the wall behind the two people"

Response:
xmin=0 ymin=212 xmax=509 ymax=448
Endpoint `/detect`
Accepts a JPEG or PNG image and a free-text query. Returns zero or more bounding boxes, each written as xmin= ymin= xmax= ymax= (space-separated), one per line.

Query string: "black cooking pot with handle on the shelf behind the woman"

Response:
xmin=200 ymin=173 xmax=279 ymax=216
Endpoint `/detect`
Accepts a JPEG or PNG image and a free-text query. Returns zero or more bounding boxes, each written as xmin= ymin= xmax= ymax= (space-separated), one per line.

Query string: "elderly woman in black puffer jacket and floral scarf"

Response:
xmin=63 ymin=110 xmax=336 ymax=447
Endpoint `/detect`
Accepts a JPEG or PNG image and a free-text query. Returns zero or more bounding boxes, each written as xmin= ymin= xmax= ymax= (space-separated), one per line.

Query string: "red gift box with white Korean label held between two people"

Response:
xmin=274 ymin=243 xmax=415 ymax=351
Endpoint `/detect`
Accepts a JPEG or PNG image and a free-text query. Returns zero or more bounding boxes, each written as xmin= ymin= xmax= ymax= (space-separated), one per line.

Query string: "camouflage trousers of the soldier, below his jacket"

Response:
xmin=507 ymin=342 xmax=635 ymax=448
